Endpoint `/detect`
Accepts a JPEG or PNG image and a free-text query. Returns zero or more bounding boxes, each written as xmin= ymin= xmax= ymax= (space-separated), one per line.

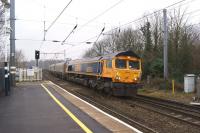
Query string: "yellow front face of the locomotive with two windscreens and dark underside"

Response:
xmin=109 ymin=51 xmax=142 ymax=96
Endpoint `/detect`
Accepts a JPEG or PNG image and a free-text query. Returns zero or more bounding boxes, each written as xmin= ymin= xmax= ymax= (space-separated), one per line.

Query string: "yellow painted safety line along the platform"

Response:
xmin=41 ymin=84 xmax=93 ymax=133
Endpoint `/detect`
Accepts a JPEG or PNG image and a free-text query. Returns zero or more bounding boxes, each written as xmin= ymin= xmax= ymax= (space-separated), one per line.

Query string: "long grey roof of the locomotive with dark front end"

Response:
xmin=69 ymin=51 xmax=140 ymax=65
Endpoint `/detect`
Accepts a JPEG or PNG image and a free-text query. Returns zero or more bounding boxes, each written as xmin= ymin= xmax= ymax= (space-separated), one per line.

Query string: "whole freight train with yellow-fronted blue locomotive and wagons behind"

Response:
xmin=49 ymin=51 xmax=142 ymax=96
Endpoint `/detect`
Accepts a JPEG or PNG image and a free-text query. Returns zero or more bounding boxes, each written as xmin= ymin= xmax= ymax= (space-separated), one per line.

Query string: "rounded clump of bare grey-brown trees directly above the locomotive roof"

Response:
xmin=84 ymin=28 xmax=143 ymax=57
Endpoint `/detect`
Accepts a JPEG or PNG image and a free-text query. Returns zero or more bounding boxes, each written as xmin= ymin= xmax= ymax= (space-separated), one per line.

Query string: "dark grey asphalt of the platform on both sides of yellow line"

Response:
xmin=0 ymin=82 xmax=110 ymax=133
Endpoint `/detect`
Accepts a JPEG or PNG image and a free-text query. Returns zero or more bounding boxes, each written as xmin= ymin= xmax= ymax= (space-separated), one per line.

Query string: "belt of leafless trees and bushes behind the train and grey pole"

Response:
xmin=85 ymin=8 xmax=200 ymax=79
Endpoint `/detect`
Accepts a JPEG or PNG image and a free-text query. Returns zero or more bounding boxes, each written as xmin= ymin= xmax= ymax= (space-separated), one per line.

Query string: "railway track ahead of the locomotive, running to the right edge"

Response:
xmin=130 ymin=95 xmax=200 ymax=127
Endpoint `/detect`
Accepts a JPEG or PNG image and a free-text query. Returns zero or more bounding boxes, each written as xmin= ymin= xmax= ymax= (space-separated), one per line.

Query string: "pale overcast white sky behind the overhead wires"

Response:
xmin=15 ymin=0 xmax=200 ymax=60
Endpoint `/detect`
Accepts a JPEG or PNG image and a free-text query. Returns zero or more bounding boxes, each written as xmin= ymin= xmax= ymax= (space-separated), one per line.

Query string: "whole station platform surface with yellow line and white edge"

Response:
xmin=0 ymin=81 xmax=140 ymax=133
